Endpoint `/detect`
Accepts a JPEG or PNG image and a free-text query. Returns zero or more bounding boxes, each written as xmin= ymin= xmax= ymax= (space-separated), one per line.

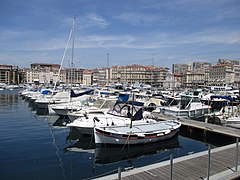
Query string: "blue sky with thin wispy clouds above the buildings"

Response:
xmin=0 ymin=0 xmax=240 ymax=68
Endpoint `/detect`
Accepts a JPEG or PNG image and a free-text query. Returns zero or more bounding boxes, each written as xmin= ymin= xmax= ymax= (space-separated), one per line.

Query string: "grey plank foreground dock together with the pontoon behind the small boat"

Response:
xmin=94 ymin=115 xmax=240 ymax=180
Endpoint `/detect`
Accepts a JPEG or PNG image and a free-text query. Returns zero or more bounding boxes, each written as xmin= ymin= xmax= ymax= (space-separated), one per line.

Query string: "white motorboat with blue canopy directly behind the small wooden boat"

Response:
xmin=67 ymin=100 xmax=156 ymax=135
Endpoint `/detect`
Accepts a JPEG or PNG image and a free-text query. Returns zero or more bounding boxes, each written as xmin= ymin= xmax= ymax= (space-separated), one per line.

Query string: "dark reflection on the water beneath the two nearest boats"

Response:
xmin=65 ymin=128 xmax=181 ymax=165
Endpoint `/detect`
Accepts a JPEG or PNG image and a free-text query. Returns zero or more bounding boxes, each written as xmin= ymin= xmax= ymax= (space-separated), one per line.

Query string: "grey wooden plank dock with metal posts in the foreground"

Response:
xmin=94 ymin=144 xmax=240 ymax=180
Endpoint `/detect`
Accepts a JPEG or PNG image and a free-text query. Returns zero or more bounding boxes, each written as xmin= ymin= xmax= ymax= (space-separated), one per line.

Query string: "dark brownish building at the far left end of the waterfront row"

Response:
xmin=0 ymin=64 xmax=21 ymax=84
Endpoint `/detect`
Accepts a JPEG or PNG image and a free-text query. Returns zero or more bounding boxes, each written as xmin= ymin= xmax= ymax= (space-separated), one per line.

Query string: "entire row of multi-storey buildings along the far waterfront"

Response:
xmin=3 ymin=59 xmax=240 ymax=89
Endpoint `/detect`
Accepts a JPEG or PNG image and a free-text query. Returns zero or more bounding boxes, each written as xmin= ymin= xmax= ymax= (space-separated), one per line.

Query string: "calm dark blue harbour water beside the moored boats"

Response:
xmin=0 ymin=90 xmax=234 ymax=180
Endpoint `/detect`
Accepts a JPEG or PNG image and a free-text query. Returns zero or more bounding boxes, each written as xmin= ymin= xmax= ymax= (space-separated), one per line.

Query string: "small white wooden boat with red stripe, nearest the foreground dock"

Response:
xmin=94 ymin=114 xmax=181 ymax=145
